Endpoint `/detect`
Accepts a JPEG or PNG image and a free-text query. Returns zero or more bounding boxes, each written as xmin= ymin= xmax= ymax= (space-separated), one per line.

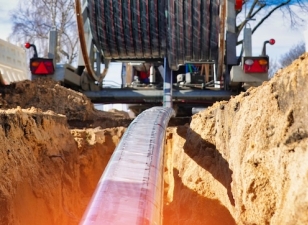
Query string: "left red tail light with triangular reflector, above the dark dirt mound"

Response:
xmin=30 ymin=58 xmax=55 ymax=75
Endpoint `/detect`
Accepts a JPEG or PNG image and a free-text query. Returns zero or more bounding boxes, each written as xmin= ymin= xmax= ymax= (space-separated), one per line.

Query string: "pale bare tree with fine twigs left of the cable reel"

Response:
xmin=10 ymin=0 xmax=78 ymax=63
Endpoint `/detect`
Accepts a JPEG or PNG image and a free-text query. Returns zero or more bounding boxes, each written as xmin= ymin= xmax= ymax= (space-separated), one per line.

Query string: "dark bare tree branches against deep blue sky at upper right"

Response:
xmin=236 ymin=0 xmax=308 ymax=55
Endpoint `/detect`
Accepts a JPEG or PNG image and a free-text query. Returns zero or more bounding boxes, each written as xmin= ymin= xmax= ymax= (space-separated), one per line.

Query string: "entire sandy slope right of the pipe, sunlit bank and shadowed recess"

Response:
xmin=165 ymin=54 xmax=308 ymax=224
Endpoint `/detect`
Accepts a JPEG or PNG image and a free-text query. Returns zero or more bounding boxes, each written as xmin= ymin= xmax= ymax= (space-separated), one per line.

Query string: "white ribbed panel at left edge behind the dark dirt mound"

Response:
xmin=0 ymin=39 xmax=30 ymax=85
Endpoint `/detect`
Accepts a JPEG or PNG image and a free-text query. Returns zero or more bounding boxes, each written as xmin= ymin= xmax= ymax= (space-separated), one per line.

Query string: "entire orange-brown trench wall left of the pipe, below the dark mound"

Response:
xmin=0 ymin=108 xmax=125 ymax=225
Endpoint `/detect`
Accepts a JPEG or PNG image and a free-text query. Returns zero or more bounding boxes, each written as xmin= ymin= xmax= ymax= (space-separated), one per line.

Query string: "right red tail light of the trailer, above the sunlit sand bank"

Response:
xmin=242 ymin=56 xmax=269 ymax=73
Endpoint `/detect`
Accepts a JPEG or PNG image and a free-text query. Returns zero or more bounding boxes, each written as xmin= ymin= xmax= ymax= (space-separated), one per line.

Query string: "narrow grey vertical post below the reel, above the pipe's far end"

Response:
xmin=163 ymin=57 xmax=172 ymax=108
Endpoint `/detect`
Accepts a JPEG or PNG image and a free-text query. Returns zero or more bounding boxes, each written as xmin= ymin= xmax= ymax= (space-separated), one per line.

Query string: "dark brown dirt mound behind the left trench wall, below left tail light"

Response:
xmin=0 ymin=78 xmax=131 ymax=128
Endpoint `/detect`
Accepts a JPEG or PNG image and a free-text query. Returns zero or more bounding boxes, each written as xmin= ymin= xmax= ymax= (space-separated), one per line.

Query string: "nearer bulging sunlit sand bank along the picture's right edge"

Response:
xmin=174 ymin=54 xmax=308 ymax=224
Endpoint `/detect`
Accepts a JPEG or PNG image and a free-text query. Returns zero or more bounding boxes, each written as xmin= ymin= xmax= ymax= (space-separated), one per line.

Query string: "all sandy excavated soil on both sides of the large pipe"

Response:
xmin=0 ymin=54 xmax=308 ymax=225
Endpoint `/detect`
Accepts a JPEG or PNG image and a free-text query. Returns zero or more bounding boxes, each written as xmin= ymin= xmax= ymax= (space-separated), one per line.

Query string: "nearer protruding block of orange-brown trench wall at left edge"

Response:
xmin=0 ymin=108 xmax=78 ymax=224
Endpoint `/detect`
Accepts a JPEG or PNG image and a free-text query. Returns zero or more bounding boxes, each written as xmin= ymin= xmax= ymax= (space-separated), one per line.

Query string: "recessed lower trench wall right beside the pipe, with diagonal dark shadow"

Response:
xmin=163 ymin=125 xmax=235 ymax=225
